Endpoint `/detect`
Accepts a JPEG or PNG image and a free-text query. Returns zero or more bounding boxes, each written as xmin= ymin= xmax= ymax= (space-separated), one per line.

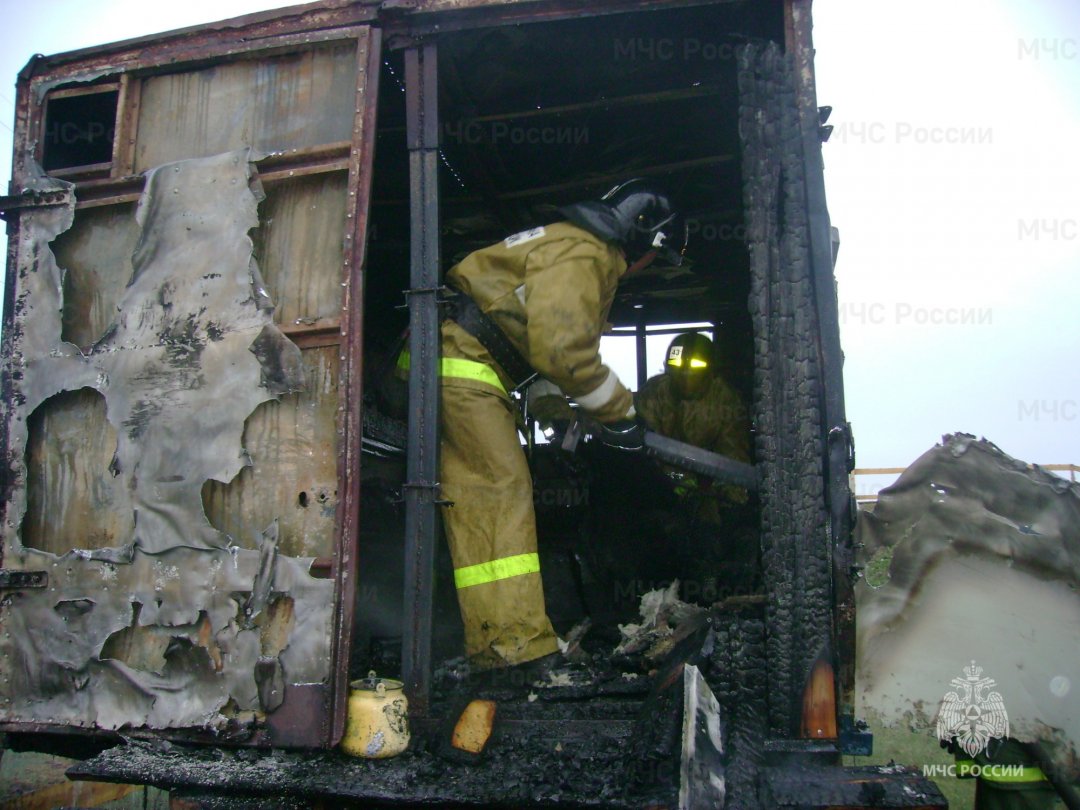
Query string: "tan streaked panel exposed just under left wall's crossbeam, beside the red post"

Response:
xmin=255 ymin=172 xmax=348 ymax=324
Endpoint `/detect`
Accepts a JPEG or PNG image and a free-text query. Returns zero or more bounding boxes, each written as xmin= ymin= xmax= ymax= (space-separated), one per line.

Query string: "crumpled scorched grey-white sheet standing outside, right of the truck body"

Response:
xmin=856 ymin=434 xmax=1080 ymax=782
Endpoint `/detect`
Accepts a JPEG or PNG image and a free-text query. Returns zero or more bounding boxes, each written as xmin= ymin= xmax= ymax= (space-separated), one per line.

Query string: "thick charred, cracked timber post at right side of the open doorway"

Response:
xmin=737 ymin=43 xmax=833 ymax=738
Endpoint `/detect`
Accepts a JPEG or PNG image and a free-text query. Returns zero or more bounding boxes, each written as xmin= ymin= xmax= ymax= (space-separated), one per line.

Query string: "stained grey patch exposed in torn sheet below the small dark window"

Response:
xmin=52 ymin=205 xmax=138 ymax=347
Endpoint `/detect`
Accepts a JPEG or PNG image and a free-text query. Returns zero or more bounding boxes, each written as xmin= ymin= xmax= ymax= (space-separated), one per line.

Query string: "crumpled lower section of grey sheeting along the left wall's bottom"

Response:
xmin=0 ymin=549 xmax=333 ymax=729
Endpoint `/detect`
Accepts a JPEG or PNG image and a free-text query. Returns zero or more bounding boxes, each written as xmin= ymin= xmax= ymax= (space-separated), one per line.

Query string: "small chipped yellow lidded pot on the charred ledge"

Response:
xmin=341 ymin=672 xmax=409 ymax=759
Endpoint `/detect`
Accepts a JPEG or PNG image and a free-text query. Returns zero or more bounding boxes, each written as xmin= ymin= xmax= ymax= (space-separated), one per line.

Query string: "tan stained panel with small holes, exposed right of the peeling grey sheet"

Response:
xmin=203 ymin=347 xmax=339 ymax=557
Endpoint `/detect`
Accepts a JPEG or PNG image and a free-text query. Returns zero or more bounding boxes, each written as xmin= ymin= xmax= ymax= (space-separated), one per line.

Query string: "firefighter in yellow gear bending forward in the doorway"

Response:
xmin=440 ymin=180 xmax=685 ymax=670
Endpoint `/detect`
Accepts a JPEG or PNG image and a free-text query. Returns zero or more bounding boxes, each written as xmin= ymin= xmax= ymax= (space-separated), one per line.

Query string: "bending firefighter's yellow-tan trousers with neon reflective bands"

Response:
xmin=440 ymin=323 xmax=557 ymax=669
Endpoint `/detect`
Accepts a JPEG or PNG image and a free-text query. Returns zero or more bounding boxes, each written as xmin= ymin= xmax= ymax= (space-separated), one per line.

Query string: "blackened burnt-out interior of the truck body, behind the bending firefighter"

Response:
xmin=353 ymin=0 xmax=781 ymax=691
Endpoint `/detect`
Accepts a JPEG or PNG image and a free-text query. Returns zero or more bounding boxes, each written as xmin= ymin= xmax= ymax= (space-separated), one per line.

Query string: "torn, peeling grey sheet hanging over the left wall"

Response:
xmin=0 ymin=149 xmax=333 ymax=729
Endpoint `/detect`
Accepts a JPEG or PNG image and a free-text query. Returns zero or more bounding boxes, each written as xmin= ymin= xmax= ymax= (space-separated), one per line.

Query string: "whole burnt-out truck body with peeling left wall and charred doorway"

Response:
xmin=0 ymin=0 xmax=932 ymax=807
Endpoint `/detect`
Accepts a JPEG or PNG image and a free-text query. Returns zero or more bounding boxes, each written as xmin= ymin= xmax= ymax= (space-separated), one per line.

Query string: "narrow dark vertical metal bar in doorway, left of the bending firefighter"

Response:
xmin=402 ymin=44 xmax=440 ymax=716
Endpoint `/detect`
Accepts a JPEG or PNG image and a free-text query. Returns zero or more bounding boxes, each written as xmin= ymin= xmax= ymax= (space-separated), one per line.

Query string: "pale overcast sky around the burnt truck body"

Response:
xmin=0 ymin=0 xmax=1080 ymax=488
